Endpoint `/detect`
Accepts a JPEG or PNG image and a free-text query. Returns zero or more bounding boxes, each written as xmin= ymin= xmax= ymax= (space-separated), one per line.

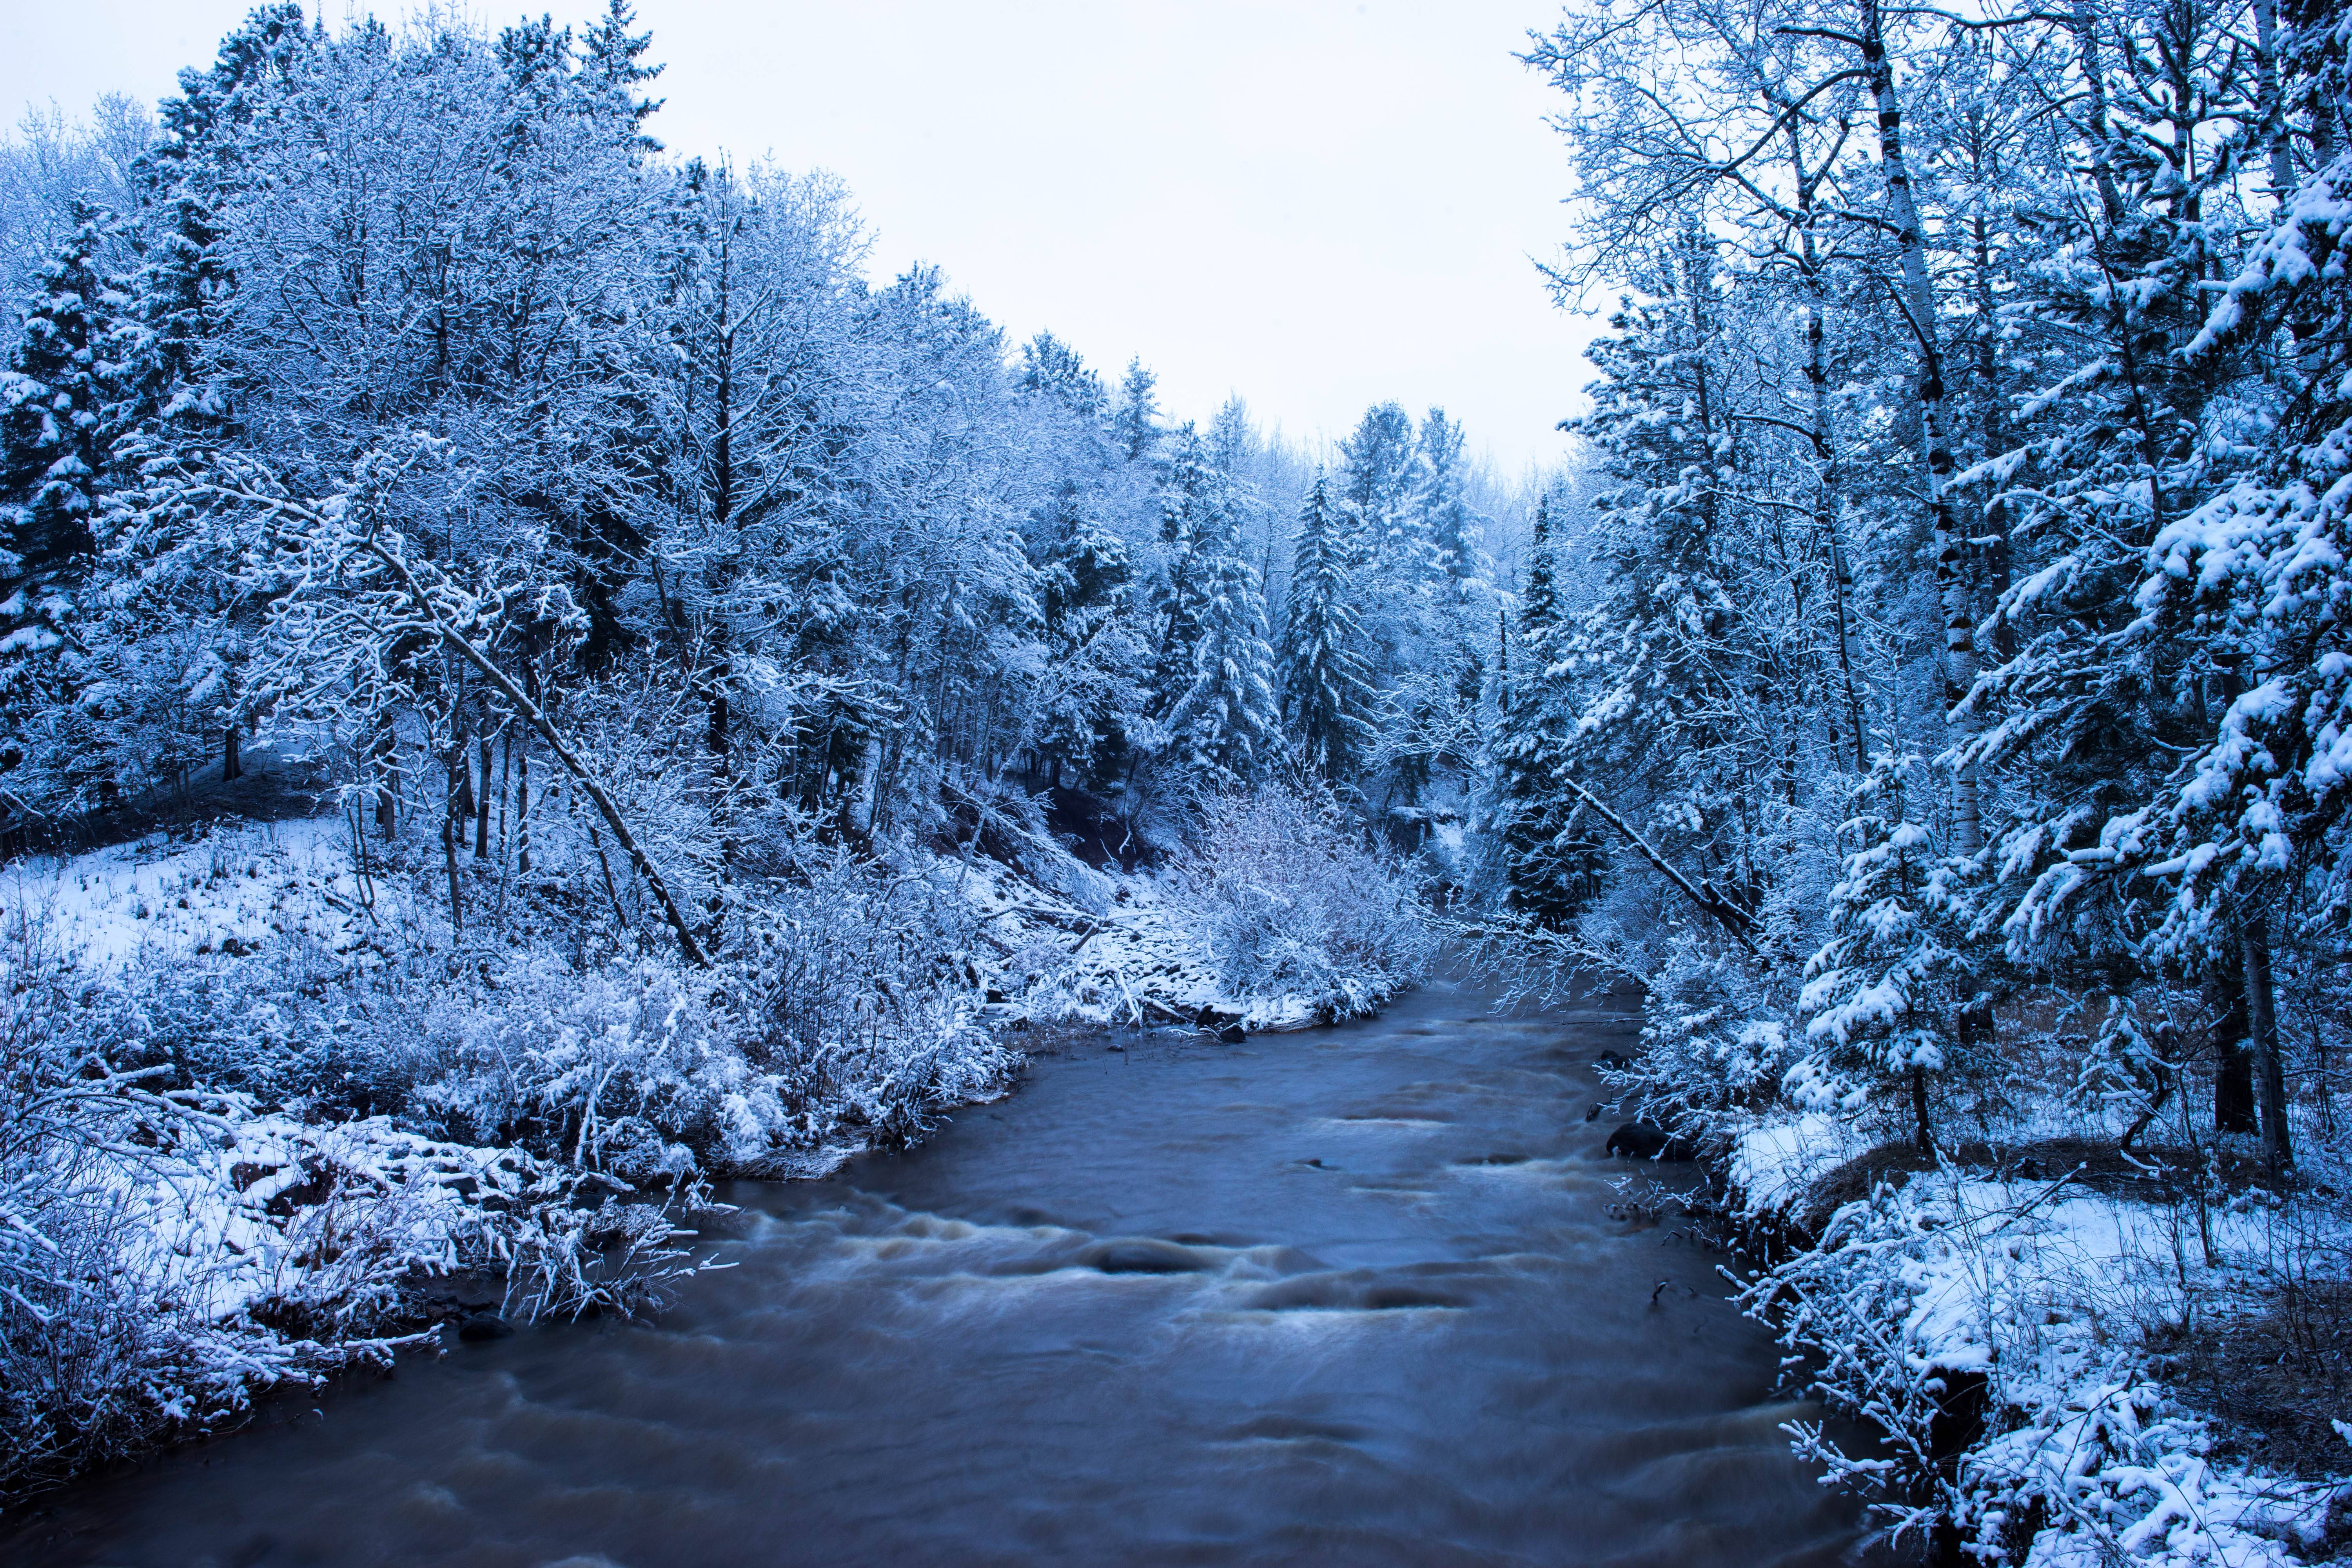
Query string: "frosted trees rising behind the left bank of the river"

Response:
xmin=0 ymin=5 xmax=1534 ymax=893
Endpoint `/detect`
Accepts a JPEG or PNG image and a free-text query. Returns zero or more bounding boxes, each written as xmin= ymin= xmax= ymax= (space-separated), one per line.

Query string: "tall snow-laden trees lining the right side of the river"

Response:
xmin=1494 ymin=0 xmax=2352 ymax=1173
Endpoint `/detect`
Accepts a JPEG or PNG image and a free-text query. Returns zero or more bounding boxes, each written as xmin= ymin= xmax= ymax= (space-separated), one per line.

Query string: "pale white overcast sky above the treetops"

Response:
xmin=0 ymin=0 xmax=1592 ymax=472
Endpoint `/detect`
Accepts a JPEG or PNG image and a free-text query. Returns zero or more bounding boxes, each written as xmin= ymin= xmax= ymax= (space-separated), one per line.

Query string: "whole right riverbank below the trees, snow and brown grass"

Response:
xmin=1724 ymin=1114 xmax=2352 ymax=1568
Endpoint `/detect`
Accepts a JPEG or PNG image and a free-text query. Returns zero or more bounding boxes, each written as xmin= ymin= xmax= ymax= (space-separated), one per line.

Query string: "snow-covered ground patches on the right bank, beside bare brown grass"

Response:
xmin=1729 ymin=1114 xmax=2352 ymax=1568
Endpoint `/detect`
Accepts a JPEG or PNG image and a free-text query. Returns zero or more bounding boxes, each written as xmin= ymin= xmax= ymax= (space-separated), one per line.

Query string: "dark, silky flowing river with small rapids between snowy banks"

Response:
xmin=0 ymin=987 xmax=1858 ymax=1568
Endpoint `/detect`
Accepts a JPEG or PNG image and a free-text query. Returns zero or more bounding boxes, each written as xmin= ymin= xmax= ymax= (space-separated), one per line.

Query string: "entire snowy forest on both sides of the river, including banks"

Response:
xmin=0 ymin=0 xmax=2352 ymax=1563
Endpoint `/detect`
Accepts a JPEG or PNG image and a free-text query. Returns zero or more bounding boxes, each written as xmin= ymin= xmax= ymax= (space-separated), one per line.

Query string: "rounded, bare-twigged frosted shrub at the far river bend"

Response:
xmin=1183 ymin=783 xmax=1435 ymax=1018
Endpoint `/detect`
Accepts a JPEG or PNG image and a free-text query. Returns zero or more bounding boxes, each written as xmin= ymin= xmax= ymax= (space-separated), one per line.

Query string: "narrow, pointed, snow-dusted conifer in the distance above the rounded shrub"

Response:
xmin=1279 ymin=472 xmax=1374 ymax=785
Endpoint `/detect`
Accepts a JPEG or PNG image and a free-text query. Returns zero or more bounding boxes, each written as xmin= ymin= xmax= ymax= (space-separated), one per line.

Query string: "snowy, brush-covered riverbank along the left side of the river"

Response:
xmin=0 ymin=806 xmax=1421 ymax=1497
